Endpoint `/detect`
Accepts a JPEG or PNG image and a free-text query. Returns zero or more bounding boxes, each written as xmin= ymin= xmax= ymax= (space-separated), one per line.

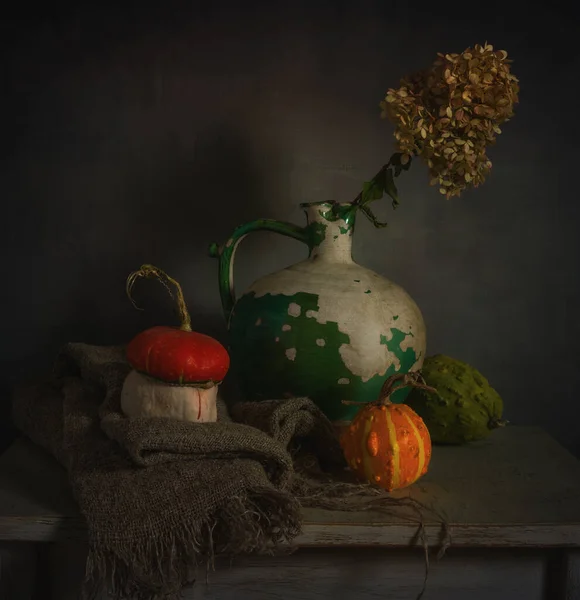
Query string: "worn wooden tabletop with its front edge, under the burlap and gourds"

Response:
xmin=0 ymin=427 xmax=580 ymax=547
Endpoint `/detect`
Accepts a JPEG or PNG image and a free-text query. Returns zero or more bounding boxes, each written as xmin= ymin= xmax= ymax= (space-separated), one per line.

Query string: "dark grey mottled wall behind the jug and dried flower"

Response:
xmin=0 ymin=1 xmax=580 ymax=454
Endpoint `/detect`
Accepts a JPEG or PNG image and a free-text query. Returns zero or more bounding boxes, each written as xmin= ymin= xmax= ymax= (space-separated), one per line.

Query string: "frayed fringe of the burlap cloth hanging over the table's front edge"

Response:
xmin=83 ymin=489 xmax=300 ymax=600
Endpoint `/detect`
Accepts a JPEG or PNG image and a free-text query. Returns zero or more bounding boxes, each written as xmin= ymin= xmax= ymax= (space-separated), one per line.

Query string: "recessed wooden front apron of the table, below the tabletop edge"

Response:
xmin=43 ymin=543 xmax=554 ymax=600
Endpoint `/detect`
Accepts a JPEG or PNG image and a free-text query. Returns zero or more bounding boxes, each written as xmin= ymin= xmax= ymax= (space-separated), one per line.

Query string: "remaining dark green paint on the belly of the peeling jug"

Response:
xmin=230 ymin=292 xmax=417 ymax=420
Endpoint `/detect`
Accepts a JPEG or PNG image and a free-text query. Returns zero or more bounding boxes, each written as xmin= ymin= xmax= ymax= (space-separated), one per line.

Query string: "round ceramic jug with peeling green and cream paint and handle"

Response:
xmin=210 ymin=202 xmax=425 ymax=426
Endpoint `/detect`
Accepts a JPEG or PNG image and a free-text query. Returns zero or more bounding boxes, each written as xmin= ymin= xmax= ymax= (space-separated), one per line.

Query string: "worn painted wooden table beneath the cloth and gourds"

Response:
xmin=0 ymin=427 xmax=580 ymax=600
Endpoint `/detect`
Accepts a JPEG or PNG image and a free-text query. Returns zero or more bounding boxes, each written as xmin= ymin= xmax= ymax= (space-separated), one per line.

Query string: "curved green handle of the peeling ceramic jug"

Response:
xmin=209 ymin=219 xmax=312 ymax=324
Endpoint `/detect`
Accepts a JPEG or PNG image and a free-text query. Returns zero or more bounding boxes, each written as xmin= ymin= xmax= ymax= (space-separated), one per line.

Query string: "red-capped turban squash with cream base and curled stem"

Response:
xmin=121 ymin=265 xmax=230 ymax=422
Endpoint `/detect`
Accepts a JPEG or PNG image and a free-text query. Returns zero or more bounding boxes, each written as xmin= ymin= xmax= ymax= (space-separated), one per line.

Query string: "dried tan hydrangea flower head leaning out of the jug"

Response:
xmin=381 ymin=43 xmax=519 ymax=198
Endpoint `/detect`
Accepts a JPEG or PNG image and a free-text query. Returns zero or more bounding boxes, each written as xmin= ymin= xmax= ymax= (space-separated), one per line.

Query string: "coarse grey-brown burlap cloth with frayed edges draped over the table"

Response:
xmin=13 ymin=343 xmax=448 ymax=600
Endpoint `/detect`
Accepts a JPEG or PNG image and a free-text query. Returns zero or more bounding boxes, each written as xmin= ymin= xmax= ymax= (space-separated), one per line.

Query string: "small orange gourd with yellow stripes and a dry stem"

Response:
xmin=340 ymin=373 xmax=435 ymax=492
